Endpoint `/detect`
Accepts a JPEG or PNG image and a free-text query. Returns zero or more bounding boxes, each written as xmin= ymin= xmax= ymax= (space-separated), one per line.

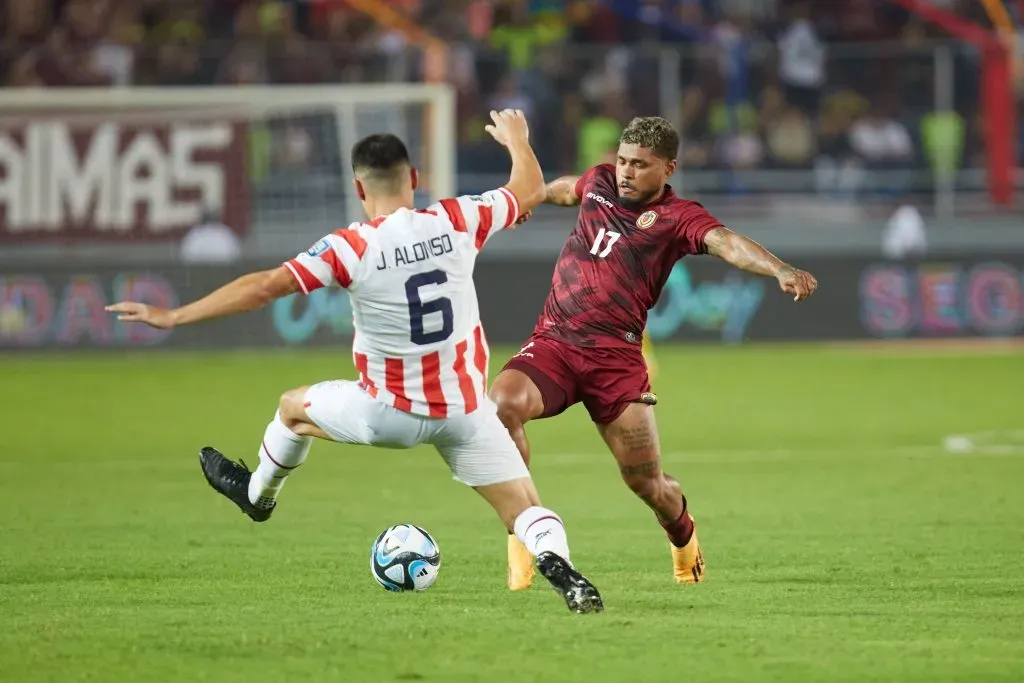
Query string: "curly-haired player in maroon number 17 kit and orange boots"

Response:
xmin=490 ymin=117 xmax=817 ymax=590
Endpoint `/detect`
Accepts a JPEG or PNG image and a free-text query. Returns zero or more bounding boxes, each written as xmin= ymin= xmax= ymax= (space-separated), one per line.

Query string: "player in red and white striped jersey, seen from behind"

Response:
xmin=109 ymin=110 xmax=603 ymax=612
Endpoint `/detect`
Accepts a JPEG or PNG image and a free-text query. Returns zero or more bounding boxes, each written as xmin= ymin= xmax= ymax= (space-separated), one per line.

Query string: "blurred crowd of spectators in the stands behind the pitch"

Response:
xmin=0 ymin=0 xmax=1024 ymax=188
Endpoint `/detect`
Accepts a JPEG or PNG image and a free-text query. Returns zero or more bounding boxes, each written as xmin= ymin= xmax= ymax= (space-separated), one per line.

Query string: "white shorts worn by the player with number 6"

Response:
xmin=305 ymin=380 xmax=529 ymax=486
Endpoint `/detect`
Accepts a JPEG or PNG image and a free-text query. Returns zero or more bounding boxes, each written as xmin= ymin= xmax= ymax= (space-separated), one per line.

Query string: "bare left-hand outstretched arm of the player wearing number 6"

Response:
xmin=106 ymin=266 xmax=299 ymax=330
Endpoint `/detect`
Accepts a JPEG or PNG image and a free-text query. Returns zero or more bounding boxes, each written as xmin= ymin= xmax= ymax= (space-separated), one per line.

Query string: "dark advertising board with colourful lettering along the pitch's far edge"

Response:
xmin=0 ymin=255 xmax=1024 ymax=349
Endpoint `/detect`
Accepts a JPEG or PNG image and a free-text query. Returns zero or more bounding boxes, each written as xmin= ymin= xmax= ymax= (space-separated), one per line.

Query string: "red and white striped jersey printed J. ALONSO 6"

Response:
xmin=285 ymin=187 xmax=519 ymax=418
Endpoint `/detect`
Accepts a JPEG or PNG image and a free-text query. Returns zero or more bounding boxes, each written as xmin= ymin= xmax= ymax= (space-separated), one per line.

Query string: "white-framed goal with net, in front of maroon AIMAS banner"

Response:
xmin=0 ymin=84 xmax=455 ymax=255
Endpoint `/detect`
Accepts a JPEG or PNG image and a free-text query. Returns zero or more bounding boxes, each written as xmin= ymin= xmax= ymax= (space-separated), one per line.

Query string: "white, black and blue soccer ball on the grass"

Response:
xmin=370 ymin=524 xmax=441 ymax=592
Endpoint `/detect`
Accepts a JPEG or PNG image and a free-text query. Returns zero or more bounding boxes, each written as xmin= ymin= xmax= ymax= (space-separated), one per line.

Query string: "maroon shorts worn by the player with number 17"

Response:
xmin=503 ymin=335 xmax=657 ymax=425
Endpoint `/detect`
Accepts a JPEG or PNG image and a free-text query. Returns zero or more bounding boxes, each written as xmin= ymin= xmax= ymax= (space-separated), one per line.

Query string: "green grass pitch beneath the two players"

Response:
xmin=0 ymin=346 xmax=1024 ymax=683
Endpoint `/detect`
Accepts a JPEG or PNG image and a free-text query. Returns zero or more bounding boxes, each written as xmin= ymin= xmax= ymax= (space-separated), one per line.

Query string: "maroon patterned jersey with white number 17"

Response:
xmin=535 ymin=164 xmax=721 ymax=346
